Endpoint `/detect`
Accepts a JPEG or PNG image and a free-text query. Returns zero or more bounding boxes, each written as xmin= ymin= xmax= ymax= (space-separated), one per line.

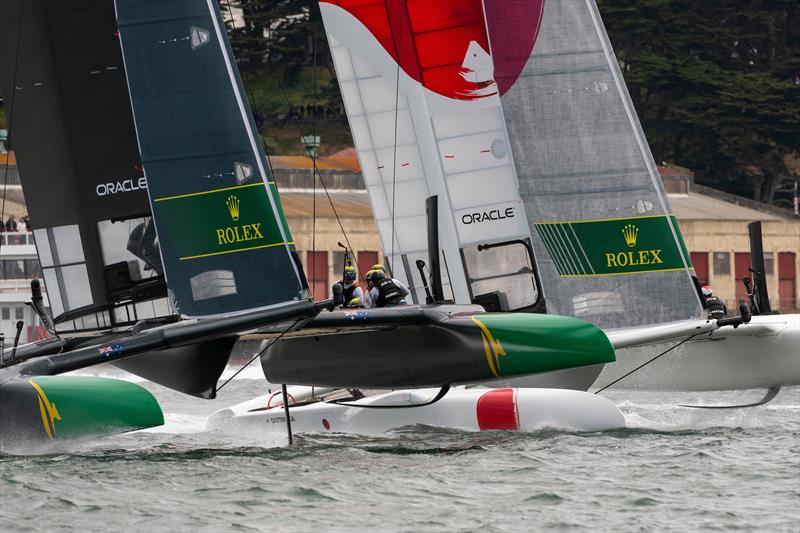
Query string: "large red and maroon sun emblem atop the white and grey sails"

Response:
xmin=320 ymin=0 xmax=544 ymax=100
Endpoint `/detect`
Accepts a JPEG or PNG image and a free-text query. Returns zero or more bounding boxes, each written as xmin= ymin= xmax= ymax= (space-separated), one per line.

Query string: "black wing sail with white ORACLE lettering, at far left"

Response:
xmin=0 ymin=0 xmax=170 ymax=330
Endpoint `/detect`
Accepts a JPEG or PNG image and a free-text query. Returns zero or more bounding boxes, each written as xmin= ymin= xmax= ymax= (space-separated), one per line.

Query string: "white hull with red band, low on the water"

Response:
xmin=207 ymin=387 xmax=625 ymax=437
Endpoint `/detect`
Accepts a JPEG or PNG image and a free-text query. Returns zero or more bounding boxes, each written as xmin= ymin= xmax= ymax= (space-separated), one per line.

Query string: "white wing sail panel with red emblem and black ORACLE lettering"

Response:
xmin=321 ymin=1 xmax=540 ymax=309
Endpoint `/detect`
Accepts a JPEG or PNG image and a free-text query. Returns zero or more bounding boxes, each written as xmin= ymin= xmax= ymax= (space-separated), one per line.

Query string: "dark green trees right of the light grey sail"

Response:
xmin=598 ymin=0 xmax=800 ymax=203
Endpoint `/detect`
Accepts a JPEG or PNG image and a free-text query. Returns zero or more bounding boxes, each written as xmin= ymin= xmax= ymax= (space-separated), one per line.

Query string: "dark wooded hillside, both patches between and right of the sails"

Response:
xmin=228 ymin=0 xmax=800 ymax=207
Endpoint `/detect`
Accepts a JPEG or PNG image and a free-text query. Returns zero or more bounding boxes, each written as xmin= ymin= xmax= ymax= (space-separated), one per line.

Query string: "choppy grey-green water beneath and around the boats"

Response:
xmin=0 ymin=369 xmax=800 ymax=532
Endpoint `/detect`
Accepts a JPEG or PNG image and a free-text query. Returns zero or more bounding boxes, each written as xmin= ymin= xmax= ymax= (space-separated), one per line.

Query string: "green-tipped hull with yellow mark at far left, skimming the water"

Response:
xmin=0 ymin=376 xmax=164 ymax=450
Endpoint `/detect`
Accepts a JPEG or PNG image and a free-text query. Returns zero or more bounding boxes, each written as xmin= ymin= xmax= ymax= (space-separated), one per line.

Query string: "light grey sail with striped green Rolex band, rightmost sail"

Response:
xmin=496 ymin=0 xmax=701 ymax=328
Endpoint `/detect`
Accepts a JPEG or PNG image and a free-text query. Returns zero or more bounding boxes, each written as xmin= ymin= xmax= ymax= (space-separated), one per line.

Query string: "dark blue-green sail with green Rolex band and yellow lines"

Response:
xmin=115 ymin=0 xmax=307 ymax=317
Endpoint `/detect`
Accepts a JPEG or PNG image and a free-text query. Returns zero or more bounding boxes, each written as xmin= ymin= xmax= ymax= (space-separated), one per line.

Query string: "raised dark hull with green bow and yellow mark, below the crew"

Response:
xmin=261 ymin=305 xmax=615 ymax=388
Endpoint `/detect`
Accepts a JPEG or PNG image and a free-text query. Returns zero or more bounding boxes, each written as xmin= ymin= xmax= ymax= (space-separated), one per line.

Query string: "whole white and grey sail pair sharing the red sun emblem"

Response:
xmin=320 ymin=0 xmax=700 ymax=327
